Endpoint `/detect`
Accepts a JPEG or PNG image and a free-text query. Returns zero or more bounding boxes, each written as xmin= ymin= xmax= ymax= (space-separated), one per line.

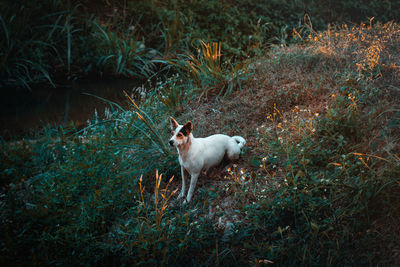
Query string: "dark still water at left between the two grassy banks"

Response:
xmin=0 ymin=80 xmax=140 ymax=137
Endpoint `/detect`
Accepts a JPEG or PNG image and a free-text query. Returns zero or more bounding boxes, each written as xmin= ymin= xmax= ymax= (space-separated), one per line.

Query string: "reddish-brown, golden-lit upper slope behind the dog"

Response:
xmin=184 ymin=22 xmax=400 ymax=156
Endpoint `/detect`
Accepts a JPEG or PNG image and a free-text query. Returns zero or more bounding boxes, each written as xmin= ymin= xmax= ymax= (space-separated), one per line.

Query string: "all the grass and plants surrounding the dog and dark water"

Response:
xmin=0 ymin=0 xmax=400 ymax=266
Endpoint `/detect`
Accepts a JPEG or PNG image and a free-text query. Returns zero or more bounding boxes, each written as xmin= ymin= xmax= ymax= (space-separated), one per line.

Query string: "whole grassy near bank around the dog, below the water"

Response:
xmin=0 ymin=18 xmax=400 ymax=266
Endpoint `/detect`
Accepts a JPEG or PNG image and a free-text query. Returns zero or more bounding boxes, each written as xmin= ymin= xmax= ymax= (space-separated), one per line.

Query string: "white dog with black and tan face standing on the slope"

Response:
xmin=169 ymin=117 xmax=246 ymax=203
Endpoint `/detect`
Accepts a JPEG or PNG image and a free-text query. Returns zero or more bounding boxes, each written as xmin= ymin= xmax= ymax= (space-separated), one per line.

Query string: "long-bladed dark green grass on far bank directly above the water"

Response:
xmin=0 ymin=1 xmax=158 ymax=88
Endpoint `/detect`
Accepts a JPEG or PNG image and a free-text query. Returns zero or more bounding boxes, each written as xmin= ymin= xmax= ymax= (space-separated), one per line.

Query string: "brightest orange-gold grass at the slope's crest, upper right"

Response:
xmin=302 ymin=19 xmax=400 ymax=79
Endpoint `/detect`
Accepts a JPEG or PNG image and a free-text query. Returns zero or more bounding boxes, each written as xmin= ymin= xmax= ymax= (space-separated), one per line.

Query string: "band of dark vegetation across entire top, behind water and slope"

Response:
xmin=0 ymin=0 xmax=400 ymax=88
